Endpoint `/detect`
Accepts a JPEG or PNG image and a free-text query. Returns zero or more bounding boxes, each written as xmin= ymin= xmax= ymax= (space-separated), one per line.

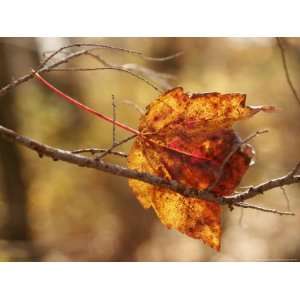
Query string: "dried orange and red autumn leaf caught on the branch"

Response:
xmin=128 ymin=87 xmax=273 ymax=250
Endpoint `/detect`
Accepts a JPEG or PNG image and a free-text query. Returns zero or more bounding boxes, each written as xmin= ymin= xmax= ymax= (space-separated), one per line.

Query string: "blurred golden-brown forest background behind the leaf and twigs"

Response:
xmin=0 ymin=38 xmax=300 ymax=261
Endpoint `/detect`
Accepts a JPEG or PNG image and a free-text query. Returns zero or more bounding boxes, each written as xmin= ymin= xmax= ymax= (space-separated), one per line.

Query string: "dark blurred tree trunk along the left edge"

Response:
xmin=0 ymin=38 xmax=38 ymax=260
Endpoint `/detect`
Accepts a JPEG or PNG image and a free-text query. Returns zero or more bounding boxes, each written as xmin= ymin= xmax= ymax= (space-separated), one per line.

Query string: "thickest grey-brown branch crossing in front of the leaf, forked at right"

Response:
xmin=0 ymin=125 xmax=300 ymax=215
